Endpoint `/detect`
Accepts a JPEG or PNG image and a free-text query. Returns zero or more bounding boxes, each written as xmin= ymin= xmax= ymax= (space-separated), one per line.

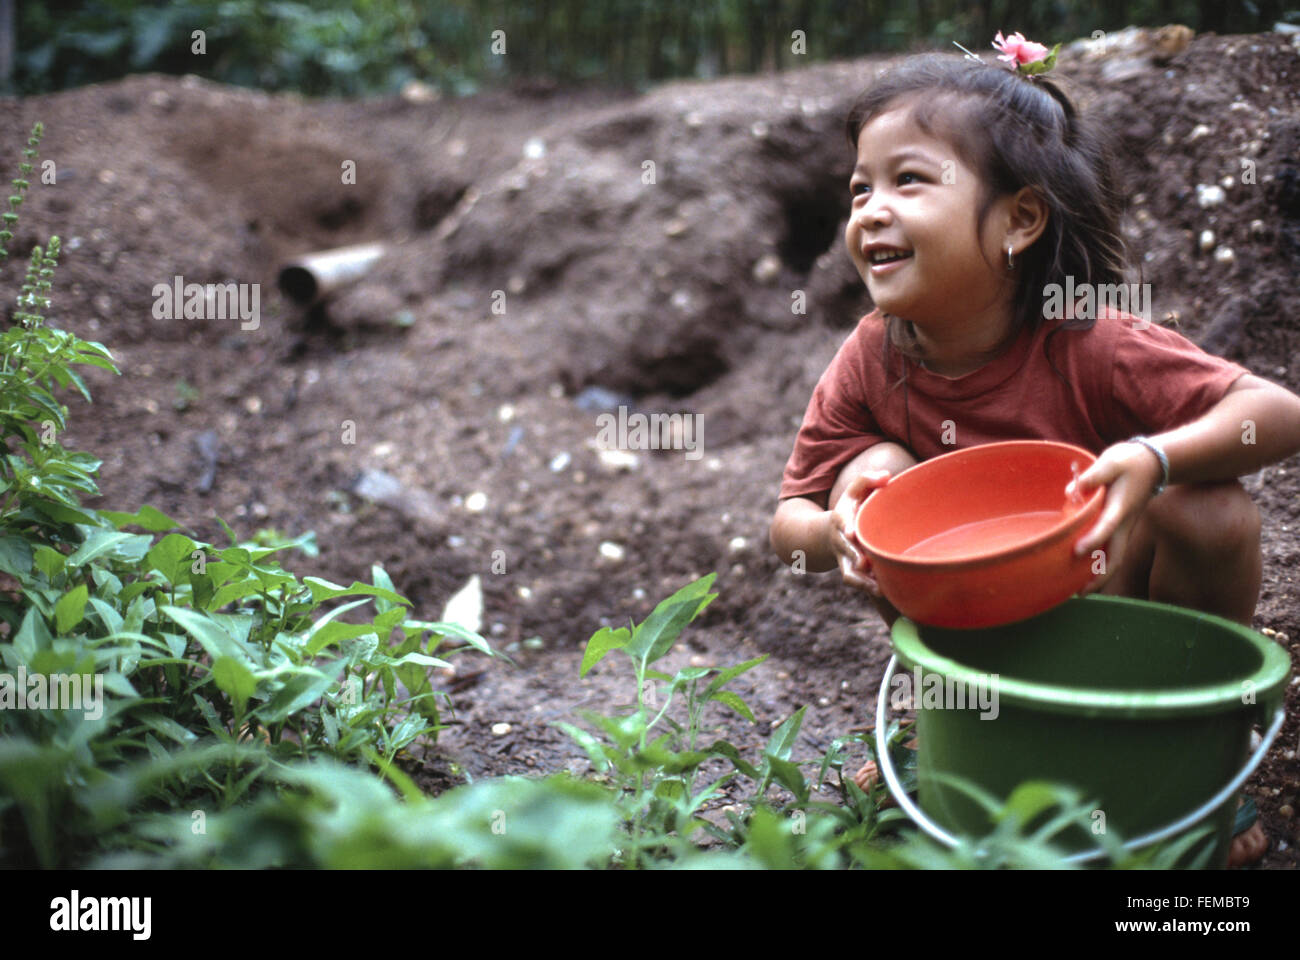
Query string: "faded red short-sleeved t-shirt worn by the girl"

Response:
xmin=780 ymin=311 xmax=1248 ymax=500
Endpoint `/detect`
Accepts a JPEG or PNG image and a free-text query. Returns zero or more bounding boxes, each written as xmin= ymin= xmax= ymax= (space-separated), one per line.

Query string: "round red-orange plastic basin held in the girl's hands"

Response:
xmin=857 ymin=440 xmax=1106 ymax=628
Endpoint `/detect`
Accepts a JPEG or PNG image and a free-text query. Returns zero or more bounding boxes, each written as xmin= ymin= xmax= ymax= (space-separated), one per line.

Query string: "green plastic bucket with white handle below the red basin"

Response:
xmin=876 ymin=596 xmax=1291 ymax=866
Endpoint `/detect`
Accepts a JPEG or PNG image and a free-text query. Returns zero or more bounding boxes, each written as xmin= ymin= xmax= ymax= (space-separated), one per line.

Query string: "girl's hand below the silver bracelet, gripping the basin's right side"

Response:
xmin=1066 ymin=442 xmax=1164 ymax=594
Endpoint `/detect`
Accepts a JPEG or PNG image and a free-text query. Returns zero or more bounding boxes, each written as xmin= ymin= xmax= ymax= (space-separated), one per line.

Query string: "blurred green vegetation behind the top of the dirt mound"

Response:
xmin=10 ymin=0 xmax=1300 ymax=95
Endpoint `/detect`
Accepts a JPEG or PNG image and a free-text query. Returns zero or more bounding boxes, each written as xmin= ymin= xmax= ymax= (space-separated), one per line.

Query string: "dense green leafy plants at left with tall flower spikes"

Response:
xmin=0 ymin=124 xmax=498 ymax=866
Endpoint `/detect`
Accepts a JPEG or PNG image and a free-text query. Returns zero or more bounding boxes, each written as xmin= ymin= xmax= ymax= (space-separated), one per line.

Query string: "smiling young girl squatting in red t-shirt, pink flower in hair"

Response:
xmin=771 ymin=35 xmax=1300 ymax=865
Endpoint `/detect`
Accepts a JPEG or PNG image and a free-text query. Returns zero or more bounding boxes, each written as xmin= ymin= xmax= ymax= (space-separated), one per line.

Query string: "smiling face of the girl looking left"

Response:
xmin=844 ymin=108 xmax=1014 ymax=336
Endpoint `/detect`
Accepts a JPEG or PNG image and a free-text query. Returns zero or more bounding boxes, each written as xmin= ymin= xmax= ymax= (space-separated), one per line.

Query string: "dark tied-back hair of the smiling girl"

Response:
xmin=845 ymin=53 xmax=1126 ymax=375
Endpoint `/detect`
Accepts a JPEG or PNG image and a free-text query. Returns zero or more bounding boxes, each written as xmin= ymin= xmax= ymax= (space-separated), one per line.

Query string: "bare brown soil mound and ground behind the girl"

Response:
xmin=0 ymin=34 xmax=1300 ymax=868
